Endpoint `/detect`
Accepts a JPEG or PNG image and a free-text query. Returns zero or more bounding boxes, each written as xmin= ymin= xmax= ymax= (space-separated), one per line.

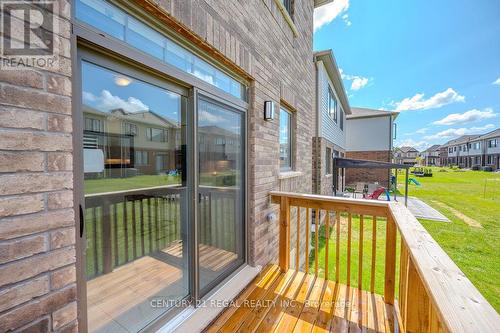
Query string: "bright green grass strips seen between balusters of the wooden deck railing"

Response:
xmin=309 ymin=214 xmax=400 ymax=295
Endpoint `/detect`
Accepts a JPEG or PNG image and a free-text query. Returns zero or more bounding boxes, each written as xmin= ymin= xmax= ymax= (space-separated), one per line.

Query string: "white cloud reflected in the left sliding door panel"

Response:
xmin=83 ymin=90 xmax=149 ymax=113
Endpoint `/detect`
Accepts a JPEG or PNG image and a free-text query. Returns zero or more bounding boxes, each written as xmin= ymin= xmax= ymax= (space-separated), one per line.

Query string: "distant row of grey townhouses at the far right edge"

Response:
xmin=444 ymin=129 xmax=500 ymax=170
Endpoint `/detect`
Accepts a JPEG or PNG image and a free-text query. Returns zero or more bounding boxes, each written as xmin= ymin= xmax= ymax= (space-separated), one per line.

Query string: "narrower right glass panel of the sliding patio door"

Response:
xmin=197 ymin=98 xmax=245 ymax=294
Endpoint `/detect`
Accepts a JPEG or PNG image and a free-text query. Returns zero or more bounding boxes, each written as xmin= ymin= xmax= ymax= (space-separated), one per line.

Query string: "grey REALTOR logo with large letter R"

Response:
xmin=0 ymin=0 xmax=58 ymax=69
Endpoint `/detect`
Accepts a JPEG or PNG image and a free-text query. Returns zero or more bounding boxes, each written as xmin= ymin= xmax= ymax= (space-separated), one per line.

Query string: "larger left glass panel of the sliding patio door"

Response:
xmin=81 ymin=61 xmax=189 ymax=332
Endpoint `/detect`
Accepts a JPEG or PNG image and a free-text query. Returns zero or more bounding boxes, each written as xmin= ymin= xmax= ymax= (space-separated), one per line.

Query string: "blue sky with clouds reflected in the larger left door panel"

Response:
xmin=82 ymin=62 xmax=181 ymax=124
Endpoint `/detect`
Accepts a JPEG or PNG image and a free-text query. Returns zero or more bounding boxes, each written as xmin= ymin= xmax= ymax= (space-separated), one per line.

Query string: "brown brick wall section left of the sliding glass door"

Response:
xmin=0 ymin=0 xmax=77 ymax=332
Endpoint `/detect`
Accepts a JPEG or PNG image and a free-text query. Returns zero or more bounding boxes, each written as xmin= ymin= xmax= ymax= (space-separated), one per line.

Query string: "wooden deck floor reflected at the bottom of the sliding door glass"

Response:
xmin=87 ymin=241 xmax=237 ymax=332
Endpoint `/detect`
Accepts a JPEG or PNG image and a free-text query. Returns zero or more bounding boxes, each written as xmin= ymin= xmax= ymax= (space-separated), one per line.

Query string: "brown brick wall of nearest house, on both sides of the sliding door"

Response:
xmin=0 ymin=0 xmax=314 ymax=332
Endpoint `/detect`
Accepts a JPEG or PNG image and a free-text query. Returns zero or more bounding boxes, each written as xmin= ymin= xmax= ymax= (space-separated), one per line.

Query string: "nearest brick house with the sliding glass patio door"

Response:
xmin=0 ymin=0 xmax=326 ymax=332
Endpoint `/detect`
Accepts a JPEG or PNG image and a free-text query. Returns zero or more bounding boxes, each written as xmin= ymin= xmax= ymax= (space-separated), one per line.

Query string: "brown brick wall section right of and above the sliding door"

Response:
xmin=148 ymin=0 xmax=315 ymax=265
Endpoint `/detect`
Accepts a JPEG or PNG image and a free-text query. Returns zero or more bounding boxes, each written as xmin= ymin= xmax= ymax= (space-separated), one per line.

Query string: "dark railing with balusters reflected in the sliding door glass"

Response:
xmin=84 ymin=186 xmax=241 ymax=279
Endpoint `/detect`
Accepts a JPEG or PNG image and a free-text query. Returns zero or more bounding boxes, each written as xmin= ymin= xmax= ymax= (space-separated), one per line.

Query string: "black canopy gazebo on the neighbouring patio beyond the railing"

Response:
xmin=333 ymin=157 xmax=411 ymax=206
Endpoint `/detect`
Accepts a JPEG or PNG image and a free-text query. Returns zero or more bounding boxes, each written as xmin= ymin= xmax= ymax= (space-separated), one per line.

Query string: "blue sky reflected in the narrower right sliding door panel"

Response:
xmin=198 ymin=100 xmax=241 ymax=135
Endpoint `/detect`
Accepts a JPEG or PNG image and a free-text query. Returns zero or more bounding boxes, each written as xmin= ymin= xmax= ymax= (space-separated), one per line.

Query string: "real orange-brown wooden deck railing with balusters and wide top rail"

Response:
xmin=271 ymin=192 xmax=500 ymax=332
